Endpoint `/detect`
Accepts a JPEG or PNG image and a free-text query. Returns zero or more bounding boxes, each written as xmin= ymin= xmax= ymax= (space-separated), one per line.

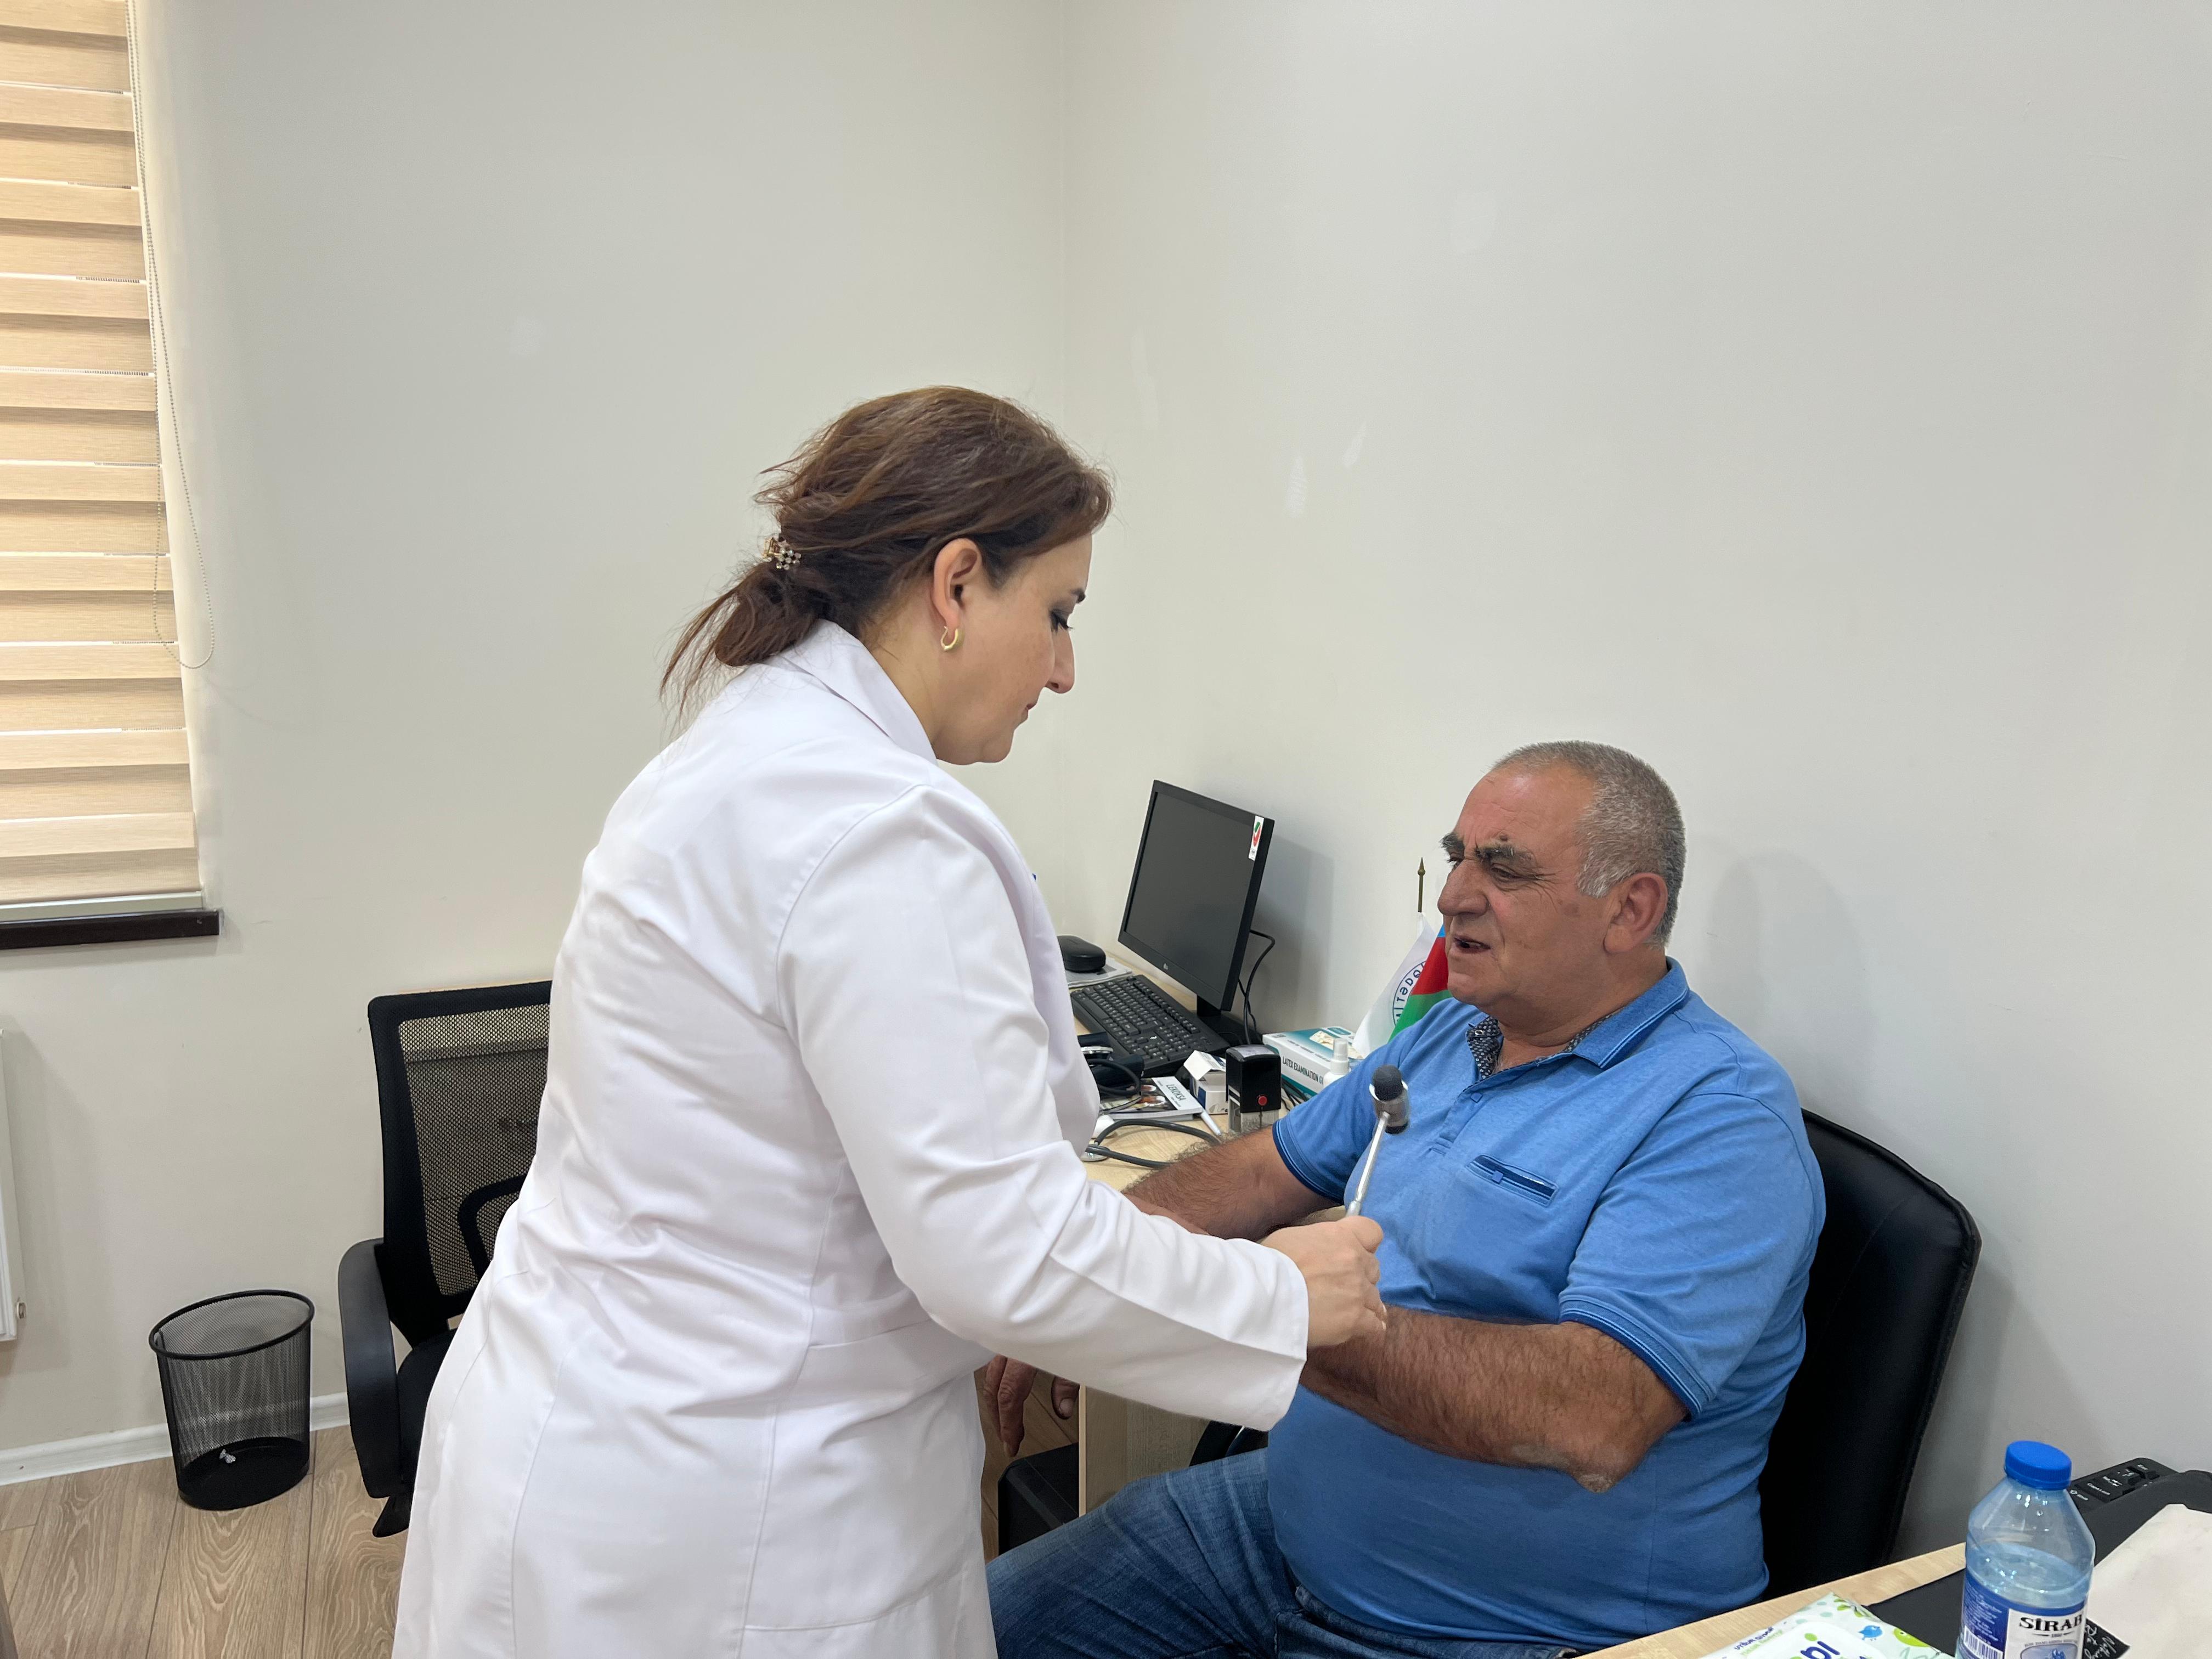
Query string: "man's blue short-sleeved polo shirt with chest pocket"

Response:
xmin=1267 ymin=962 xmax=1825 ymax=1648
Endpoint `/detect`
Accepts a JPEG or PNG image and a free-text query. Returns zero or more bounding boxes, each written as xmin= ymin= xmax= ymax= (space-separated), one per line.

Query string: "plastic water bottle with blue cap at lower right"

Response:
xmin=1957 ymin=1440 xmax=2097 ymax=1659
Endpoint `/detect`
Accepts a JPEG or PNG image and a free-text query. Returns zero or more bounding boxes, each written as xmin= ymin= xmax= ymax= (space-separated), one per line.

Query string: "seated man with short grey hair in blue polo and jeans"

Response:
xmin=991 ymin=743 xmax=1822 ymax=1659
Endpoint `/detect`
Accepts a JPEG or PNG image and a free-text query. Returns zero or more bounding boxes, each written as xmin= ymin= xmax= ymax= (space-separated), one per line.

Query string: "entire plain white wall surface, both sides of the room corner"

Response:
xmin=0 ymin=0 xmax=2212 ymax=1575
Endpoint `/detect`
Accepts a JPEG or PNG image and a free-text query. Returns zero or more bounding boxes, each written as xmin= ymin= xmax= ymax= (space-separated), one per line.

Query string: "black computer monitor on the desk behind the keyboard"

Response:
xmin=1121 ymin=781 xmax=1274 ymax=1040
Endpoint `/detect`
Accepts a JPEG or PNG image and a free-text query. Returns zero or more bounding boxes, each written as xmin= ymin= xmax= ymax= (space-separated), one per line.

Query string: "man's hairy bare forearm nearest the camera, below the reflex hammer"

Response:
xmin=1305 ymin=1307 xmax=1681 ymax=1491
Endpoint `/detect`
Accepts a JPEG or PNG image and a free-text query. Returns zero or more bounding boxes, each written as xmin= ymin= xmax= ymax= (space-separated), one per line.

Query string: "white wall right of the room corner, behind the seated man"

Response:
xmin=978 ymin=0 xmax=2212 ymax=1544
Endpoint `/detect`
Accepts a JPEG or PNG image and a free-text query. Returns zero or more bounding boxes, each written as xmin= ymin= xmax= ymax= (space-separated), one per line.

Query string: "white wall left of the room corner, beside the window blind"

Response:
xmin=0 ymin=0 xmax=1062 ymax=1447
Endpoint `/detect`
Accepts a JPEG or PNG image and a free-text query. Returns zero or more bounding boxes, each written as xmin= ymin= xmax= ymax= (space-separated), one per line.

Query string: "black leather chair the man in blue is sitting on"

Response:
xmin=997 ymin=1113 xmax=1982 ymax=1595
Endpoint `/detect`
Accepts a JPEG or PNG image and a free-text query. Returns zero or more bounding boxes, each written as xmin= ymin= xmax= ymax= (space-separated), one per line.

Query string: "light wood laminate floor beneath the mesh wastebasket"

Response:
xmin=0 ymin=1374 xmax=1075 ymax=1659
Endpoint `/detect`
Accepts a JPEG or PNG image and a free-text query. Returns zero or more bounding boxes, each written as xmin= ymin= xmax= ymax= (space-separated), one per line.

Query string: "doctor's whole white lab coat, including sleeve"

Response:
xmin=394 ymin=624 xmax=1305 ymax=1659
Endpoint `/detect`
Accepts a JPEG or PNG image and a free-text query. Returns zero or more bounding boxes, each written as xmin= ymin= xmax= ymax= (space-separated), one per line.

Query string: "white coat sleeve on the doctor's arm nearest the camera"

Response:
xmin=778 ymin=789 xmax=1305 ymax=1427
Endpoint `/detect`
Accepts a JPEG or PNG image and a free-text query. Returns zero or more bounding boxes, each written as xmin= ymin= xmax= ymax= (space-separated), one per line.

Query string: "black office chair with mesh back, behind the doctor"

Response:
xmin=338 ymin=980 xmax=553 ymax=1537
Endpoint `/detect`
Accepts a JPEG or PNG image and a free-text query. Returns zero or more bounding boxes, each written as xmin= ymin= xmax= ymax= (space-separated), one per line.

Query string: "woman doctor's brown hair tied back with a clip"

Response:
xmin=662 ymin=385 xmax=1113 ymax=706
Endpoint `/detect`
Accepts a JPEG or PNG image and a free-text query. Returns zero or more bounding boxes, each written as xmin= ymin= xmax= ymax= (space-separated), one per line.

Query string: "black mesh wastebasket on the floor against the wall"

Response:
xmin=146 ymin=1290 xmax=314 ymax=1509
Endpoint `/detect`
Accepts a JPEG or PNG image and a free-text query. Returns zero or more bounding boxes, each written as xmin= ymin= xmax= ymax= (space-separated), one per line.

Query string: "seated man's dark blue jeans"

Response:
xmin=991 ymin=1451 xmax=1571 ymax=1659
